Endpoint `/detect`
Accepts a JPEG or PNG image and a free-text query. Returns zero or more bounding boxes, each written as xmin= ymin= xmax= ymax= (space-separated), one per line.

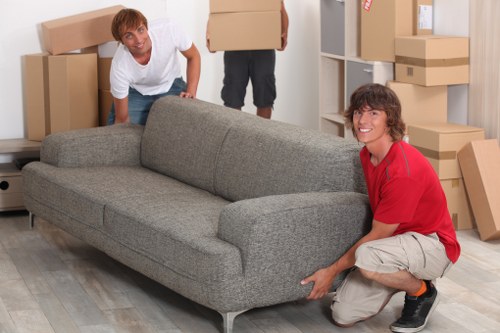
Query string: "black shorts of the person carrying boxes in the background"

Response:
xmin=221 ymin=50 xmax=276 ymax=109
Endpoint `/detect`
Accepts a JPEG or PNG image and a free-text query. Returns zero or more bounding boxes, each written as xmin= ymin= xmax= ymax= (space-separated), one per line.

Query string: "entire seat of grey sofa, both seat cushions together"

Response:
xmin=23 ymin=162 xmax=242 ymax=281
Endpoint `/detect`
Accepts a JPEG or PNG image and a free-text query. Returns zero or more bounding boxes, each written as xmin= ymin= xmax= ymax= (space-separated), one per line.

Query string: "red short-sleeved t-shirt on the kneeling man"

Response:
xmin=360 ymin=141 xmax=460 ymax=263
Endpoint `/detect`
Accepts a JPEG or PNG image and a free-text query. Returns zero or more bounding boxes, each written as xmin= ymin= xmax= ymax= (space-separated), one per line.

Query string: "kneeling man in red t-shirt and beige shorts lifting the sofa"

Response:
xmin=301 ymin=84 xmax=460 ymax=332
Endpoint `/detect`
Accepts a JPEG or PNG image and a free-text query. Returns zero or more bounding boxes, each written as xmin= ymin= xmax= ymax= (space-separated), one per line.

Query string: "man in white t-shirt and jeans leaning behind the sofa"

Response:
xmin=108 ymin=8 xmax=201 ymax=125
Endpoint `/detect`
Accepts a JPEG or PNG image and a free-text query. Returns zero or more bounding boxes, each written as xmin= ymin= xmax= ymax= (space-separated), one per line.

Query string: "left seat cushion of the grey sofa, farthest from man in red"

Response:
xmin=23 ymin=162 xmax=204 ymax=229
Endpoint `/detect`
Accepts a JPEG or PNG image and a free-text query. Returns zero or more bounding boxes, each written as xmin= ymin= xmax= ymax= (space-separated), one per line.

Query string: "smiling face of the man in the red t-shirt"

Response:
xmin=353 ymin=105 xmax=392 ymax=146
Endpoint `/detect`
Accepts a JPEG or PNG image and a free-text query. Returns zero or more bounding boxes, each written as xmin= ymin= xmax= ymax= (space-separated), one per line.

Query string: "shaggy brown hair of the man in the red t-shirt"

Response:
xmin=344 ymin=83 xmax=406 ymax=141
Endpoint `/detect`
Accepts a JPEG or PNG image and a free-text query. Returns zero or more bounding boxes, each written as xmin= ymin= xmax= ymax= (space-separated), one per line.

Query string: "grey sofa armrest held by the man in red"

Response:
xmin=218 ymin=192 xmax=372 ymax=298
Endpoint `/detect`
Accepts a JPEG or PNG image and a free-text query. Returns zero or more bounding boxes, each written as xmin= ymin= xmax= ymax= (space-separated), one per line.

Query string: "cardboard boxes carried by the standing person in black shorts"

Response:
xmin=208 ymin=0 xmax=281 ymax=51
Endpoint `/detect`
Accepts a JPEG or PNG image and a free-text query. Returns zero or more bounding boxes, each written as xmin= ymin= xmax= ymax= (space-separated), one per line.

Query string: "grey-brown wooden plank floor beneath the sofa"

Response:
xmin=0 ymin=213 xmax=500 ymax=333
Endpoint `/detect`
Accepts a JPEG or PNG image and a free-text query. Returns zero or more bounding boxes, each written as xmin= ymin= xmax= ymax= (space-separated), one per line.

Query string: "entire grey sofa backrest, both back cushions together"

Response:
xmin=141 ymin=96 xmax=365 ymax=201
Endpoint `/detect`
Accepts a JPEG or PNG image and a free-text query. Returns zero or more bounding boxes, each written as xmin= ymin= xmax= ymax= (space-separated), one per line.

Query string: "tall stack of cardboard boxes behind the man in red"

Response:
xmin=360 ymin=0 xmax=500 ymax=234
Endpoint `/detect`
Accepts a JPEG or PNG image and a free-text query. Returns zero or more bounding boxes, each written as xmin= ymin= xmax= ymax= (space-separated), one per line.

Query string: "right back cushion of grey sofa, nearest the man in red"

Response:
xmin=215 ymin=116 xmax=365 ymax=201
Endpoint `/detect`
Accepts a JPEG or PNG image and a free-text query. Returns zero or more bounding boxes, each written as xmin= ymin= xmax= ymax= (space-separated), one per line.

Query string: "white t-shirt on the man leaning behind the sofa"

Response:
xmin=110 ymin=19 xmax=193 ymax=99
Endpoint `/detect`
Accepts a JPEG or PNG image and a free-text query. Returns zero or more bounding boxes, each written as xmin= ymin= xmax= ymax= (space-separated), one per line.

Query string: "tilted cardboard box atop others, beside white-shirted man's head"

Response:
xmin=42 ymin=5 xmax=125 ymax=55
